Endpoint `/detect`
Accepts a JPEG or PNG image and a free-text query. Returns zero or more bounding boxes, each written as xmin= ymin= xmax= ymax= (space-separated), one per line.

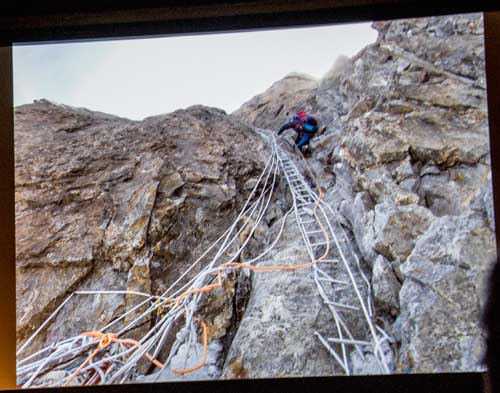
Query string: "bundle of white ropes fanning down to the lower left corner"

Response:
xmin=18 ymin=139 xmax=290 ymax=387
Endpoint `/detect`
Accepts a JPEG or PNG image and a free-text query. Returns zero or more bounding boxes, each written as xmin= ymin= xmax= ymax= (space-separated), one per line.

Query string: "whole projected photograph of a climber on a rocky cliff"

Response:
xmin=13 ymin=14 xmax=496 ymax=388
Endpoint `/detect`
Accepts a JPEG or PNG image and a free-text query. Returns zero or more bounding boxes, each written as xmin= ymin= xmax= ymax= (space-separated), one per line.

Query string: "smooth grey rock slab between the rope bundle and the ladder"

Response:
xmin=222 ymin=217 xmax=340 ymax=378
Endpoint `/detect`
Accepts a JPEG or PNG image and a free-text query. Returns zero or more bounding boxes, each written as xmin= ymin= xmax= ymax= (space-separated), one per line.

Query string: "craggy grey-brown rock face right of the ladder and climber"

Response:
xmin=234 ymin=14 xmax=496 ymax=372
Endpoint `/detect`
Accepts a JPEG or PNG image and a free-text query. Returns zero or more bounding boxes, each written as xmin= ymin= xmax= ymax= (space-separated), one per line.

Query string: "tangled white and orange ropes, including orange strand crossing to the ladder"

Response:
xmin=18 ymin=129 xmax=392 ymax=388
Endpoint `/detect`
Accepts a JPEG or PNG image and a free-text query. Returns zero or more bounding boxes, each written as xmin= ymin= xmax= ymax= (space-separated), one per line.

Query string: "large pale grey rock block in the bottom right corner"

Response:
xmin=397 ymin=213 xmax=496 ymax=372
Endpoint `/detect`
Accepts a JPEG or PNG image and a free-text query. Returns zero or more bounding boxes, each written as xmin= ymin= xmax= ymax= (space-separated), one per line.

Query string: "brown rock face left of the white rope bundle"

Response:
xmin=15 ymin=100 xmax=266 ymax=350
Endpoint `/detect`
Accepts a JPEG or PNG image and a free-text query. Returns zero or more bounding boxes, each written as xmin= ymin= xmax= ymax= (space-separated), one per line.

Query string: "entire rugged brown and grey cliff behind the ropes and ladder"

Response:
xmin=15 ymin=11 xmax=495 ymax=380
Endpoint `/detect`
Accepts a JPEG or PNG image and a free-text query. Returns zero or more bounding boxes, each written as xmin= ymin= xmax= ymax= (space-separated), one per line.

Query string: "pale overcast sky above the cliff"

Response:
xmin=13 ymin=23 xmax=377 ymax=120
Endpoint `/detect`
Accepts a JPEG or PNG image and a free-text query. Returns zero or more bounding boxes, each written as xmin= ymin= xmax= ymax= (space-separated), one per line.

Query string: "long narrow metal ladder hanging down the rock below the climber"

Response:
xmin=273 ymin=138 xmax=391 ymax=375
